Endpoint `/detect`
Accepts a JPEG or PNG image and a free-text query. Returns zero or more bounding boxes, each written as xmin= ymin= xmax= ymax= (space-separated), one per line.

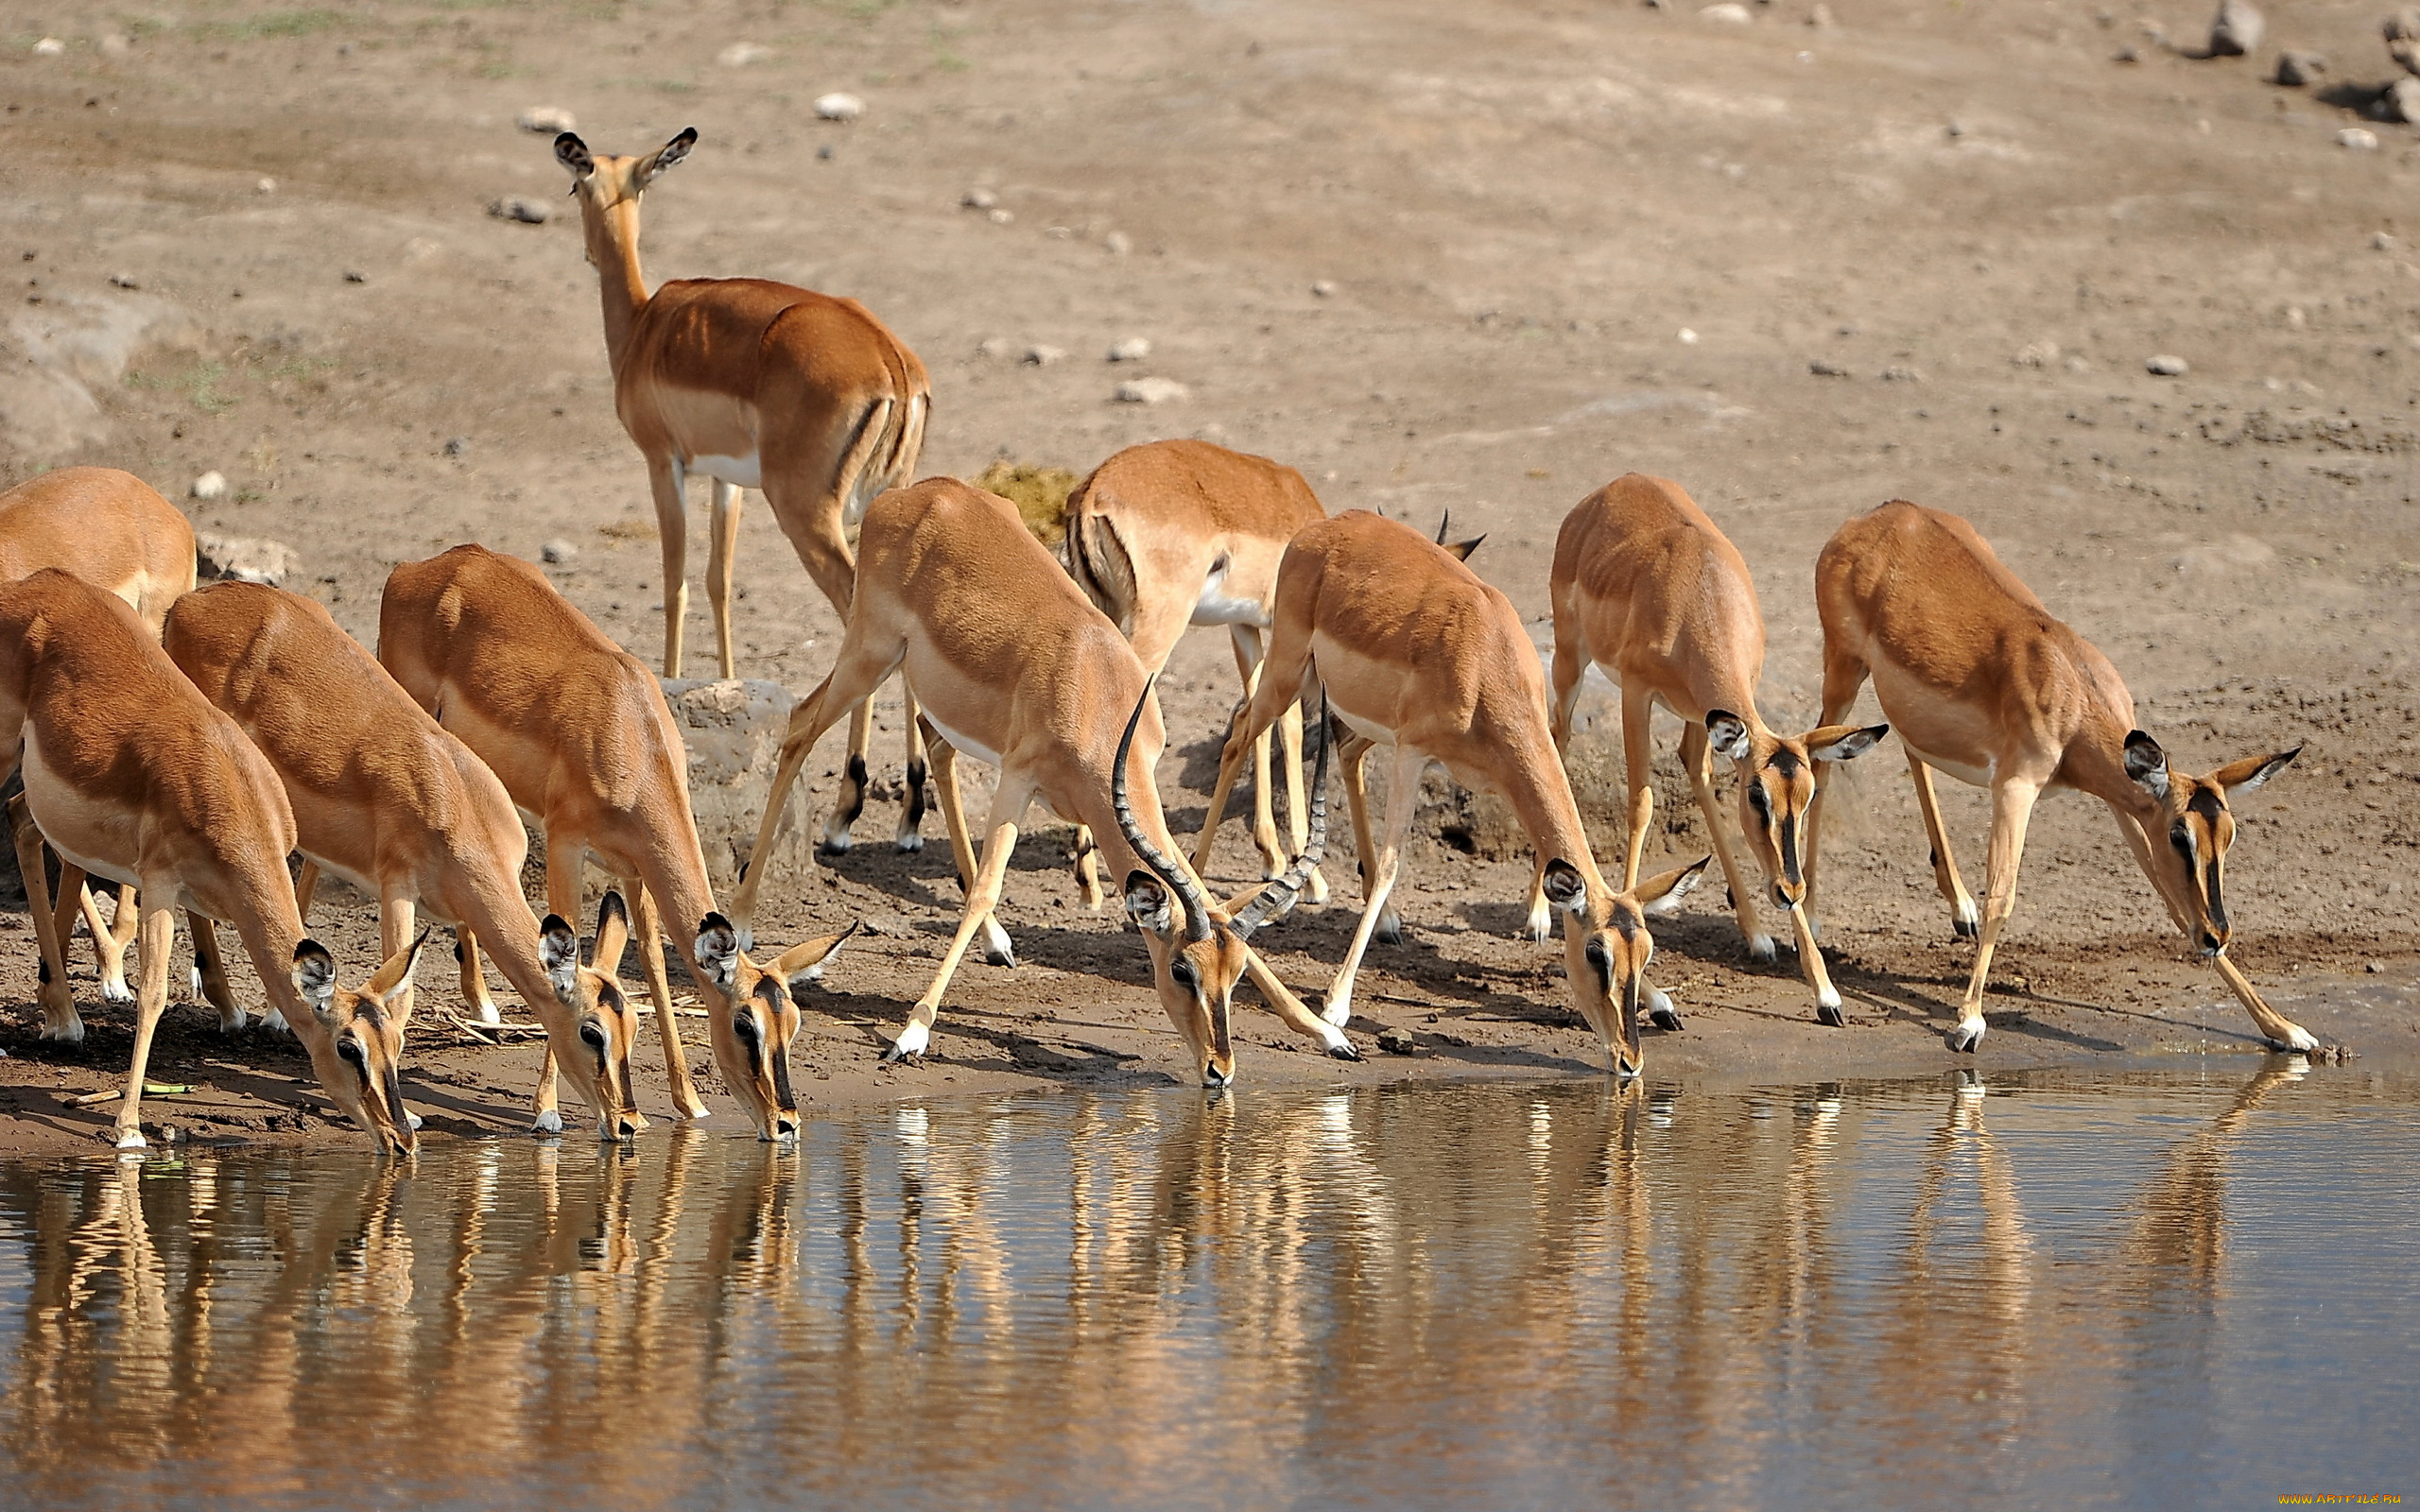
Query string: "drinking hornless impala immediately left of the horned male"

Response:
xmin=377 ymin=547 xmax=847 ymax=1140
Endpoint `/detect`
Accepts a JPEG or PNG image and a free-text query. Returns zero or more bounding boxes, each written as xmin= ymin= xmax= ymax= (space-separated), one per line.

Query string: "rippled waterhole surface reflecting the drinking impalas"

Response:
xmin=0 ymin=1062 xmax=2420 ymax=1507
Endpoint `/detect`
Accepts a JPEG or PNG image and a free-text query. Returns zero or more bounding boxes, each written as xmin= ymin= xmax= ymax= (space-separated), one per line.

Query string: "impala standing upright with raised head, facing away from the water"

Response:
xmin=554 ymin=126 xmax=932 ymax=854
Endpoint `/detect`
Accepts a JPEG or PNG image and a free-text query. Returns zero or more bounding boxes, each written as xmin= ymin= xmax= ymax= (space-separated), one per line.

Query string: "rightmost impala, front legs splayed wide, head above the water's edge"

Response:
xmin=1806 ymin=501 xmax=2318 ymax=1053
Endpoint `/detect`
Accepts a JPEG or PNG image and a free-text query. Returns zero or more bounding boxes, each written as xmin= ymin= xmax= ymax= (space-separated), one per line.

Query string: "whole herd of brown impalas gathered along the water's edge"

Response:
xmin=0 ymin=130 xmax=2316 ymax=1152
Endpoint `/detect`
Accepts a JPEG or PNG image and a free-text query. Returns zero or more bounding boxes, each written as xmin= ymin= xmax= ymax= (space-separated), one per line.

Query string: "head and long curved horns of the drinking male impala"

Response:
xmin=1108 ymin=682 xmax=1328 ymax=1086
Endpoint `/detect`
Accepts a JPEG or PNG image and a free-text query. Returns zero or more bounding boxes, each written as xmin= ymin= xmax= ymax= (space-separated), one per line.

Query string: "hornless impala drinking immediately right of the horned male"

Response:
xmin=1193 ymin=510 xmax=1711 ymax=1076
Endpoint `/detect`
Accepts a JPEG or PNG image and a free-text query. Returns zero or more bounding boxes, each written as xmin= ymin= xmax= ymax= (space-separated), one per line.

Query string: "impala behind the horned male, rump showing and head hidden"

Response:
xmin=1064 ymin=440 xmax=1328 ymax=902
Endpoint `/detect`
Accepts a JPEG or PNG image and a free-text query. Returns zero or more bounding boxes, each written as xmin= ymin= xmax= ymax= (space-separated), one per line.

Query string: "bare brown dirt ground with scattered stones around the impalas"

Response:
xmin=0 ymin=0 xmax=2420 ymax=1152
